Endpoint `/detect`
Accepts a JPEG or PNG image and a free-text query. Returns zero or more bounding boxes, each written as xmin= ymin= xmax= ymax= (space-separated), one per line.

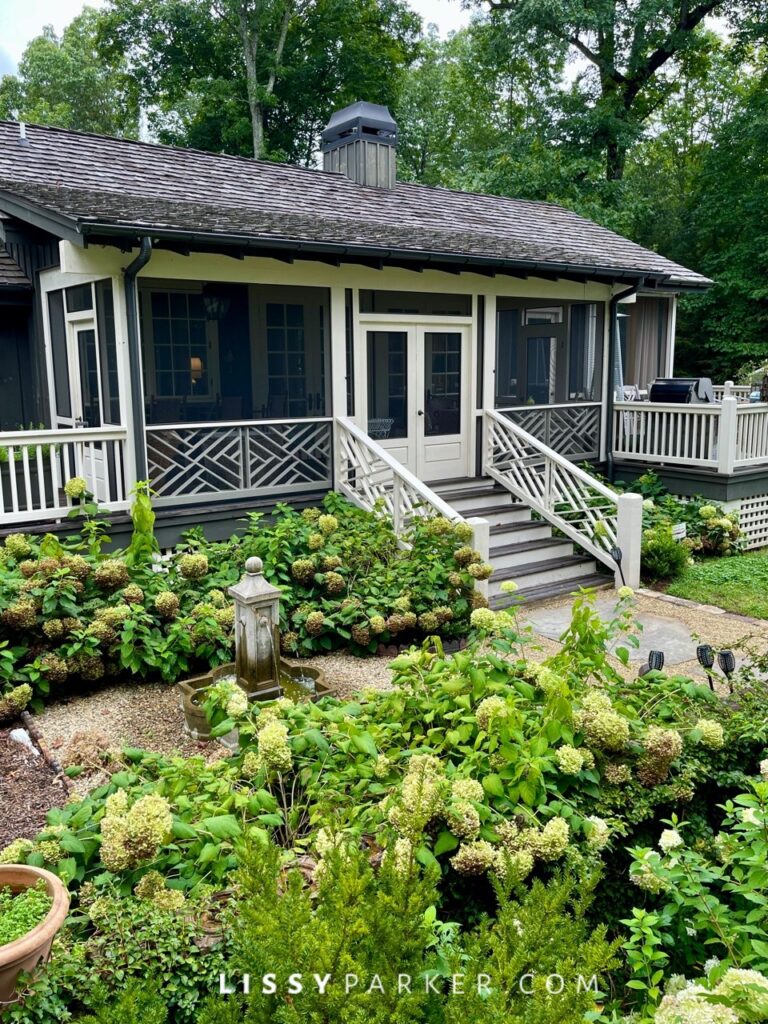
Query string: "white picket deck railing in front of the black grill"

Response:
xmin=613 ymin=395 xmax=768 ymax=474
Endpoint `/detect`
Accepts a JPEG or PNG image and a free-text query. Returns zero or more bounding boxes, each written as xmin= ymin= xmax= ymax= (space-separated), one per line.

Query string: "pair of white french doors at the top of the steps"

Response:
xmin=366 ymin=324 xmax=471 ymax=482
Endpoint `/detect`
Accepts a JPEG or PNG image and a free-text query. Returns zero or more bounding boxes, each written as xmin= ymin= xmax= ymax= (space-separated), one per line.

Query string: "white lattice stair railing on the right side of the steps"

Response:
xmin=483 ymin=409 xmax=642 ymax=587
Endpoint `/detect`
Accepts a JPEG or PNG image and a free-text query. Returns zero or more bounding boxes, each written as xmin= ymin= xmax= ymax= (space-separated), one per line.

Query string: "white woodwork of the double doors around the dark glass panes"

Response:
xmin=355 ymin=313 xmax=477 ymax=481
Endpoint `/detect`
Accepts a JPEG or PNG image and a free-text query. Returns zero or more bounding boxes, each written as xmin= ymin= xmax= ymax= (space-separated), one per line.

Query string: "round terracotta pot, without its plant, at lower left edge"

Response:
xmin=0 ymin=864 xmax=70 ymax=1016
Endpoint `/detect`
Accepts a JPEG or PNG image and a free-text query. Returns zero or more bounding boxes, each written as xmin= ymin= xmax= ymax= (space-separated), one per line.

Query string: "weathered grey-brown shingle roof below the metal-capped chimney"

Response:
xmin=0 ymin=122 xmax=710 ymax=287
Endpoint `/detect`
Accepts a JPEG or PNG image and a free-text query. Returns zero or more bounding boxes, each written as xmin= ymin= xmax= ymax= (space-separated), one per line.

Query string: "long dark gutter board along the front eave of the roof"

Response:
xmin=78 ymin=221 xmax=671 ymax=288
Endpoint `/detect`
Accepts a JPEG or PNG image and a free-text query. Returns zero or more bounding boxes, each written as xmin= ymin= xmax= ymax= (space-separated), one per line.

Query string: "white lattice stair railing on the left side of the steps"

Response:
xmin=335 ymin=416 xmax=489 ymax=573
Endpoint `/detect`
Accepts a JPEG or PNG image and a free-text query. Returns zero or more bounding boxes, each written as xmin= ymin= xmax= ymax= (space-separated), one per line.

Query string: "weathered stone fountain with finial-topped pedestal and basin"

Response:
xmin=177 ymin=558 xmax=330 ymax=739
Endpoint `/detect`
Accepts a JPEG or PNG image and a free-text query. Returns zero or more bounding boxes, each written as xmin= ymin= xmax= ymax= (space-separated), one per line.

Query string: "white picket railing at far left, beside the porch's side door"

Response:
xmin=0 ymin=427 xmax=129 ymax=526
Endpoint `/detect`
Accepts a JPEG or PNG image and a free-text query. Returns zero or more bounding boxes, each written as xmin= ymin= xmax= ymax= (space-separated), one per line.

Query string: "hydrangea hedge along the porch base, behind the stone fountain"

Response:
xmin=0 ymin=493 xmax=481 ymax=698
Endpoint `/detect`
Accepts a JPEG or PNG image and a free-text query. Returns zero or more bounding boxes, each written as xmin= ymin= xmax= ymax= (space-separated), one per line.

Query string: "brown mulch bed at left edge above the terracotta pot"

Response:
xmin=0 ymin=722 xmax=68 ymax=849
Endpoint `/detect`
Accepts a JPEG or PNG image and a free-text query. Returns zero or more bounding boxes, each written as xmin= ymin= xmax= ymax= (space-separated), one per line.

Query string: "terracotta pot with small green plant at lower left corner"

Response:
xmin=0 ymin=864 xmax=70 ymax=1014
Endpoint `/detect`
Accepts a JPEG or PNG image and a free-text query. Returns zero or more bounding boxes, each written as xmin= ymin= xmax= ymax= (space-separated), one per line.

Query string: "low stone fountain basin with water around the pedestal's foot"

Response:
xmin=176 ymin=658 xmax=331 ymax=739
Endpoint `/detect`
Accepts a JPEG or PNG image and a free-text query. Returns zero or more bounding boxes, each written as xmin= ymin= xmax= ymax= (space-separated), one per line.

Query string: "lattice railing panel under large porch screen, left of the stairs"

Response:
xmin=146 ymin=418 xmax=333 ymax=506
